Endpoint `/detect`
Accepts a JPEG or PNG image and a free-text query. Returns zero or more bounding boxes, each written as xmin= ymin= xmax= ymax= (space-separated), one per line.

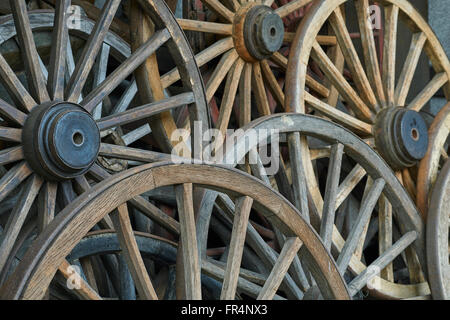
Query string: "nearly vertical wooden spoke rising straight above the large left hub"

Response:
xmin=47 ymin=0 xmax=71 ymax=100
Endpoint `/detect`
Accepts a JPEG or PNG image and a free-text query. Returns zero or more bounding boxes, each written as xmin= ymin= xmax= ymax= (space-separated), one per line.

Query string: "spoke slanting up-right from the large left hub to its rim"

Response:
xmin=81 ymin=29 xmax=170 ymax=112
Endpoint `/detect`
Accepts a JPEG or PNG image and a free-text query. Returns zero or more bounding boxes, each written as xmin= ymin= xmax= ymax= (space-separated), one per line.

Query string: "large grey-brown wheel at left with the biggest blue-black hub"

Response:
xmin=0 ymin=0 xmax=205 ymax=278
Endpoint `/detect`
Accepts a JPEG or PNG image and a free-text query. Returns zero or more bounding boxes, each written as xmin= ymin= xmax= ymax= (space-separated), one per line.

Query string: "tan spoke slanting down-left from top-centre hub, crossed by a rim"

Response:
xmin=161 ymin=37 xmax=234 ymax=88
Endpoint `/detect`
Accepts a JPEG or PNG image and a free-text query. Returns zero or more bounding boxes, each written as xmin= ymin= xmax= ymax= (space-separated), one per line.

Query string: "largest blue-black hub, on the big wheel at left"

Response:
xmin=22 ymin=102 xmax=100 ymax=181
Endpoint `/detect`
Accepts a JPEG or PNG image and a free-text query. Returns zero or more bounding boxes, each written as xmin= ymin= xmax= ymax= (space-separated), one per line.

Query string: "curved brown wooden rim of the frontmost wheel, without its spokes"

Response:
xmin=2 ymin=163 xmax=348 ymax=299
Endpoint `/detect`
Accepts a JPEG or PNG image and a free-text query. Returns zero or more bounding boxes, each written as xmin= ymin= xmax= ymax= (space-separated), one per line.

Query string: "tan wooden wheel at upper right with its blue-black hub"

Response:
xmin=286 ymin=0 xmax=450 ymax=215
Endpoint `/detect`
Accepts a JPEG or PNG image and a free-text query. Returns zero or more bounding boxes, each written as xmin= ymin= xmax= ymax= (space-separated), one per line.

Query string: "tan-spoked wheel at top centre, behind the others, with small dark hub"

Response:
xmin=165 ymin=0 xmax=335 ymax=145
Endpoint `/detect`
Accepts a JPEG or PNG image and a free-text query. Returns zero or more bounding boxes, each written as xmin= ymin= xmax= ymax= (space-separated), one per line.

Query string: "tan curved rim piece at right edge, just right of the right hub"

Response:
xmin=416 ymin=103 xmax=450 ymax=217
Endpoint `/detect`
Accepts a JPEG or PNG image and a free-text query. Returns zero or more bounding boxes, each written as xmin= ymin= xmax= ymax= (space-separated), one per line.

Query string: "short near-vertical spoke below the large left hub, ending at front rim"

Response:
xmin=38 ymin=182 xmax=58 ymax=233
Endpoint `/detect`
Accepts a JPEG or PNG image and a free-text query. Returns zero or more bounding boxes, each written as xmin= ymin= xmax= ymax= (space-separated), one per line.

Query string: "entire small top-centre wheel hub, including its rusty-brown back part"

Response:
xmin=235 ymin=5 xmax=284 ymax=61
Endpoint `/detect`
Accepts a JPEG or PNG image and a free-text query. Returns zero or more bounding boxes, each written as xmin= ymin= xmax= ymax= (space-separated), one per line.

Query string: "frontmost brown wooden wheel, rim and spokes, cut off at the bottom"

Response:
xmin=0 ymin=162 xmax=348 ymax=299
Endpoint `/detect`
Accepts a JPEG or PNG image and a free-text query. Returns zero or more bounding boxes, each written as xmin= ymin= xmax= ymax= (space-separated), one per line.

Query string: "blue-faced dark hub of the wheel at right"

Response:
xmin=374 ymin=107 xmax=428 ymax=170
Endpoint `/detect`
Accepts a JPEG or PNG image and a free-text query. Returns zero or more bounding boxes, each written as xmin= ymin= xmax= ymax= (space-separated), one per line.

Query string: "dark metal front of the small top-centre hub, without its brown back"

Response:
xmin=244 ymin=5 xmax=284 ymax=60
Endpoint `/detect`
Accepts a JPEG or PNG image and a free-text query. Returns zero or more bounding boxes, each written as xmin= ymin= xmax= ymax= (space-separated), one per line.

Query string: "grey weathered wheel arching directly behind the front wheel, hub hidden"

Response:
xmin=197 ymin=114 xmax=430 ymax=299
